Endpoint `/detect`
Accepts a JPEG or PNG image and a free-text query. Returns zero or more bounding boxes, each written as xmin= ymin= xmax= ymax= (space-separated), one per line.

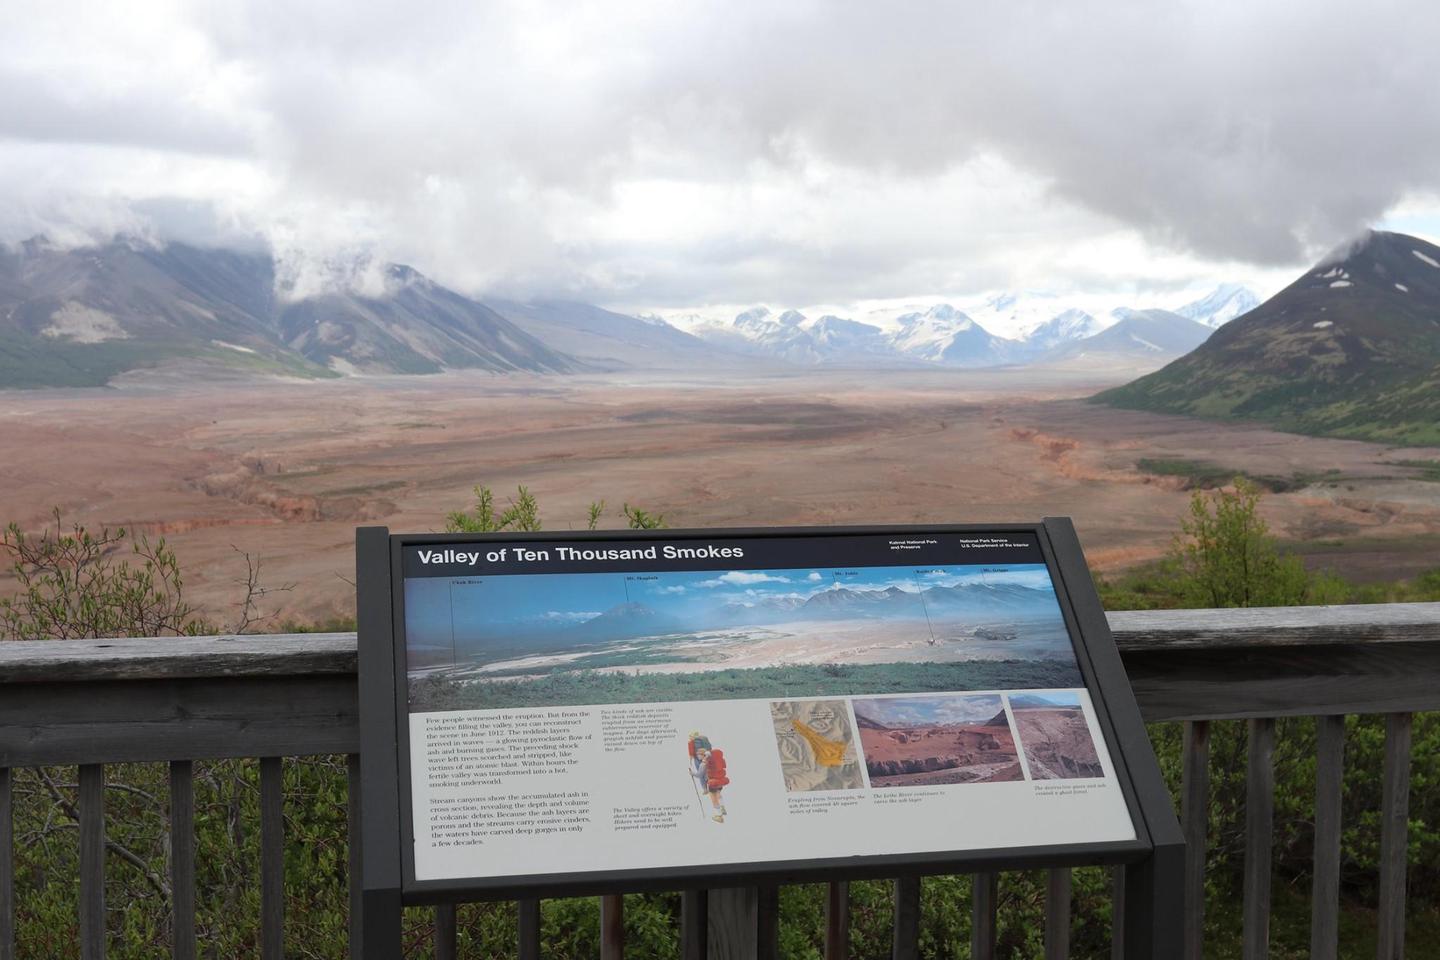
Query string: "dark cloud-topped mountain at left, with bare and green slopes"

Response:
xmin=0 ymin=240 xmax=573 ymax=389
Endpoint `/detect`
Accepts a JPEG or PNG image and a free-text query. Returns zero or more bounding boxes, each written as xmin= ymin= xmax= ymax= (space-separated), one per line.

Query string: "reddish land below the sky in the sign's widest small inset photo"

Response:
xmin=855 ymin=704 xmax=1024 ymax=787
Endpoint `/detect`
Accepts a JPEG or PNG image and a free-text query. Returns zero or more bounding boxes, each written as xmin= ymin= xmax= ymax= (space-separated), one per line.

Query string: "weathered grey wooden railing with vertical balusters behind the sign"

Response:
xmin=0 ymin=603 xmax=1440 ymax=960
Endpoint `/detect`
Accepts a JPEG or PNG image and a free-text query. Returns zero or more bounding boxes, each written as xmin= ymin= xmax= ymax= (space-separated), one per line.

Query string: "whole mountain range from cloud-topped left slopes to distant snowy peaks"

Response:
xmin=0 ymin=240 xmax=1254 ymax=389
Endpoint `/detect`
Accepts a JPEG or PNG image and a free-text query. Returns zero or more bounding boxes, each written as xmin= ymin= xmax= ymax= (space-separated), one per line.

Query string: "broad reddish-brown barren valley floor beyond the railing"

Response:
xmin=0 ymin=370 xmax=1440 ymax=620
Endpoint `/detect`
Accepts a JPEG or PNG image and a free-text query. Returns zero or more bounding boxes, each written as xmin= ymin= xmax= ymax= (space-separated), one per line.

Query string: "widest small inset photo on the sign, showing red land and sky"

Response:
xmin=852 ymin=694 xmax=1024 ymax=787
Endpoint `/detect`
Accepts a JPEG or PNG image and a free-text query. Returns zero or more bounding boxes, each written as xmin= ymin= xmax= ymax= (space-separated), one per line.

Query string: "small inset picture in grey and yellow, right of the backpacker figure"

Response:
xmin=770 ymin=699 xmax=865 ymax=793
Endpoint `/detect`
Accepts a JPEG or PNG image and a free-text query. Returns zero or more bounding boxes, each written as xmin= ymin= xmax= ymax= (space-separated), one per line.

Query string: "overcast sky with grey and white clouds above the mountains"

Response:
xmin=0 ymin=0 xmax=1440 ymax=311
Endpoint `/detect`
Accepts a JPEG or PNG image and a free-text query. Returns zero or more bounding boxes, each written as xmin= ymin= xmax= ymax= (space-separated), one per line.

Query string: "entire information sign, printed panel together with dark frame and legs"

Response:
xmin=357 ymin=518 xmax=1184 ymax=959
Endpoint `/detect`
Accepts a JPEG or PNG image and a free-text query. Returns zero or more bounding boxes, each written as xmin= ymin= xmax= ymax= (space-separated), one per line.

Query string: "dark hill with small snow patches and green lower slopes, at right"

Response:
xmin=1094 ymin=232 xmax=1440 ymax=445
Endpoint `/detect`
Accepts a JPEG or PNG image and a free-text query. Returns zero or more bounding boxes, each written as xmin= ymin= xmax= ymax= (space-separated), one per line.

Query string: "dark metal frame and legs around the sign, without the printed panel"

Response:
xmin=356 ymin=517 xmax=1185 ymax=960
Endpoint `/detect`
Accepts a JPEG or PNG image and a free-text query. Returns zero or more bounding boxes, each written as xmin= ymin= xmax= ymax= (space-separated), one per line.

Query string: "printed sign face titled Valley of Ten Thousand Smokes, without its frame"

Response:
xmin=402 ymin=531 xmax=1136 ymax=881
